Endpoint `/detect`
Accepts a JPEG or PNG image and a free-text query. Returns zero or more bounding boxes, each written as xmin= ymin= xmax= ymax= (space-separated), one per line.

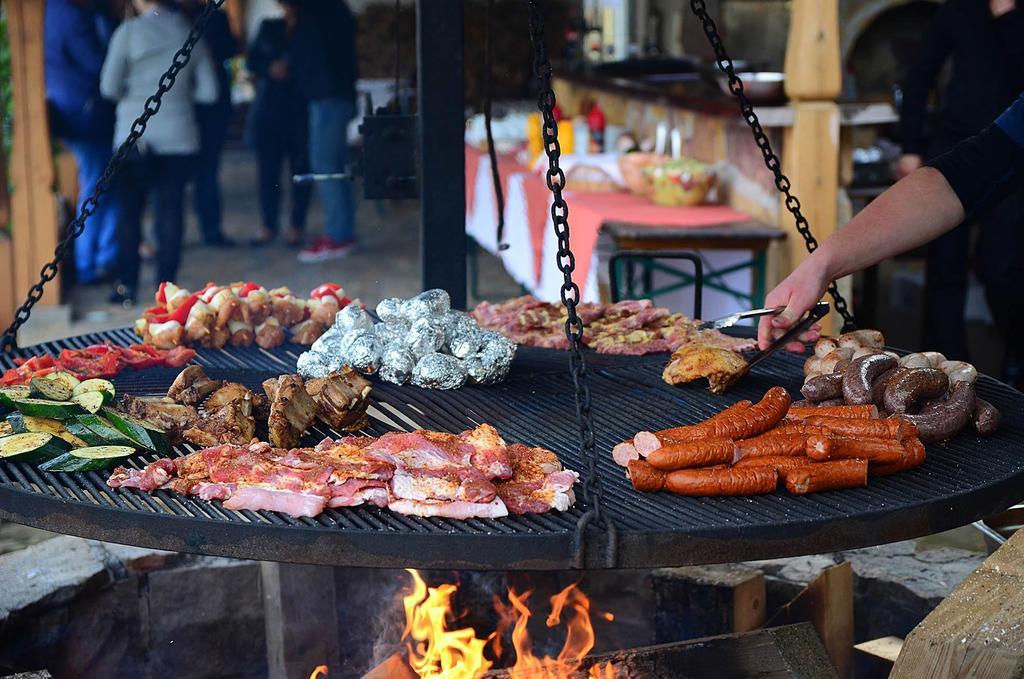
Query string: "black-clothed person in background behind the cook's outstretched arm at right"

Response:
xmin=897 ymin=0 xmax=1024 ymax=372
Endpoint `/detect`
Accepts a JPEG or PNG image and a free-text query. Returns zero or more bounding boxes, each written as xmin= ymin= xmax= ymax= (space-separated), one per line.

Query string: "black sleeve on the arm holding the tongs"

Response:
xmin=928 ymin=124 xmax=1024 ymax=219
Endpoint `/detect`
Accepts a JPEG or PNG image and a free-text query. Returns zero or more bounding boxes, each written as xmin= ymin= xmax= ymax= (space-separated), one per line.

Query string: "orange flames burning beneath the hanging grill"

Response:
xmin=402 ymin=569 xmax=615 ymax=679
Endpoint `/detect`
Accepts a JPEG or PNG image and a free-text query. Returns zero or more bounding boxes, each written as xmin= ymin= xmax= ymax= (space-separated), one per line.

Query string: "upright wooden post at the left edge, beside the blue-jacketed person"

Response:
xmin=4 ymin=0 xmax=60 ymax=311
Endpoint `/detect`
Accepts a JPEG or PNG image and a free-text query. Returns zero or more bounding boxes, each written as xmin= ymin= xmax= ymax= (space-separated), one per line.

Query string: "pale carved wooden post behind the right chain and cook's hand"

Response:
xmin=779 ymin=0 xmax=842 ymax=329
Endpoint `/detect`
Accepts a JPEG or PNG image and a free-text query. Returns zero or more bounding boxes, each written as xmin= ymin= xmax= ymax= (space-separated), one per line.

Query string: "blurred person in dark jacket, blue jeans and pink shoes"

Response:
xmin=292 ymin=0 xmax=356 ymax=262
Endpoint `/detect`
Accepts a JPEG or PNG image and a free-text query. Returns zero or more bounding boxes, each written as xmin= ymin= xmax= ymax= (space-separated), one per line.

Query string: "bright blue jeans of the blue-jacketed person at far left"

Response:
xmin=65 ymin=140 xmax=118 ymax=284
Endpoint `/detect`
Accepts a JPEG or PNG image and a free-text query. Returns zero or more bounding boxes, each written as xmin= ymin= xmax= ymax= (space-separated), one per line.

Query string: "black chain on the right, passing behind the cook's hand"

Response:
xmin=690 ymin=0 xmax=857 ymax=332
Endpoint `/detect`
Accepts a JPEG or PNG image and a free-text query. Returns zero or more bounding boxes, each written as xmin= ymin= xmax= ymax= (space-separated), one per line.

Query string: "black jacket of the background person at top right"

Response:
xmin=900 ymin=0 xmax=1024 ymax=154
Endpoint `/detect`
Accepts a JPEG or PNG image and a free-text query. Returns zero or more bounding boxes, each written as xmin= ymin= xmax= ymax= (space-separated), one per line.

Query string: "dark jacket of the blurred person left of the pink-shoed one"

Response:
xmin=246 ymin=18 xmax=308 ymax=146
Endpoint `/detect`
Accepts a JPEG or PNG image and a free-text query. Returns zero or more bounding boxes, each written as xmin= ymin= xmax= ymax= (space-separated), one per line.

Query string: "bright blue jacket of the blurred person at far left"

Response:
xmin=43 ymin=0 xmax=114 ymax=142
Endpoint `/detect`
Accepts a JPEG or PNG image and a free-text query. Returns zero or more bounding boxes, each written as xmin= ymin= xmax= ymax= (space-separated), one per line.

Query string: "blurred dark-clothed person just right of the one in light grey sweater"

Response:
xmin=179 ymin=0 xmax=239 ymax=247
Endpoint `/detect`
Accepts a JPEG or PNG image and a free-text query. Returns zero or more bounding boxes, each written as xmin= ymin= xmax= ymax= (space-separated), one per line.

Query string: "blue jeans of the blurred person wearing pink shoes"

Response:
xmin=309 ymin=97 xmax=355 ymax=243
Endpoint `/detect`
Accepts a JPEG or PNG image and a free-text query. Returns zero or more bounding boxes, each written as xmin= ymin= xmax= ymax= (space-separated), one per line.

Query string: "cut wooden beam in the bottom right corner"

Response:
xmin=890 ymin=531 xmax=1024 ymax=679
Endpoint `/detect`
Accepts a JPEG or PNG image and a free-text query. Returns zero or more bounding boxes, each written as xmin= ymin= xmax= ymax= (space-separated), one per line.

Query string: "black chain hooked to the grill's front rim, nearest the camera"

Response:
xmin=527 ymin=0 xmax=616 ymax=567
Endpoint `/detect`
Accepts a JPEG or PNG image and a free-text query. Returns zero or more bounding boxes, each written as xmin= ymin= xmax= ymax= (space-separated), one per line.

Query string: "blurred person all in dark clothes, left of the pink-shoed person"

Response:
xmin=246 ymin=0 xmax=312 ymax=246
